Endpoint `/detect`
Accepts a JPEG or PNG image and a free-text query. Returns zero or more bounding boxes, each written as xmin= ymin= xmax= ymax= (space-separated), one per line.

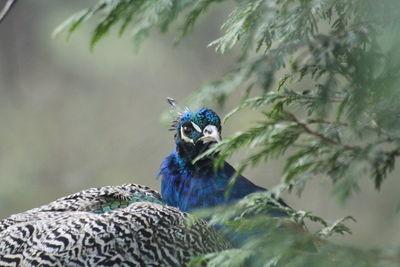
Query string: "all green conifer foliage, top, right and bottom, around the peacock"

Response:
xmin=57 ymin=0 xmax=400 ymax=266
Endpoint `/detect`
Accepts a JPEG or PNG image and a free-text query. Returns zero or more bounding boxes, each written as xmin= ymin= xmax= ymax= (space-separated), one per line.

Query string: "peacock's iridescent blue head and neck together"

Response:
xmin=159 ymin=108 xmax=286 ymax=216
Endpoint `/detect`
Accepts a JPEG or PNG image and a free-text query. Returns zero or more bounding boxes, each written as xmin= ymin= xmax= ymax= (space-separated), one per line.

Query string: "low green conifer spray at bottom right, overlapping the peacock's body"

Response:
xmin=191 ymin=192 xmax=398 ymax=266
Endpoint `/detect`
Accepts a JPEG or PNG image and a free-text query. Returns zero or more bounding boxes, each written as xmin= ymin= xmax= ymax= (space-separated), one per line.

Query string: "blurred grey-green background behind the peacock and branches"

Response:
xmin=0 ymin=0 xmax=400 ymax=247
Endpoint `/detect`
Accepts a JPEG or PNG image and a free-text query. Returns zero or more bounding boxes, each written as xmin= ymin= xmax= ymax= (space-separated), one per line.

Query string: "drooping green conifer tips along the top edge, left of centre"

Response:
xmin=54 ymin=0 xmax=220 ymax=49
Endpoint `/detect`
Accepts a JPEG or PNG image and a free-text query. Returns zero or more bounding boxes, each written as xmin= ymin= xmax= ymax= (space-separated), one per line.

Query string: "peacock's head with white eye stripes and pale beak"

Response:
xmin=174 ymin=108 xmax=221 ymax=162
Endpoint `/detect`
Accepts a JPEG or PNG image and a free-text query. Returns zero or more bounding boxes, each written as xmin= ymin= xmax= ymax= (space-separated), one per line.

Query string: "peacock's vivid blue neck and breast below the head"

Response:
xmin=161 ymin=150 xmax=265 ymax=214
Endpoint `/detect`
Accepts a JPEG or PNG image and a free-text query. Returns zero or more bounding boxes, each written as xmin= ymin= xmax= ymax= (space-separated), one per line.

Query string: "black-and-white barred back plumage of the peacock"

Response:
xmin=0 ymin=184 xmax=231 ymax=266
